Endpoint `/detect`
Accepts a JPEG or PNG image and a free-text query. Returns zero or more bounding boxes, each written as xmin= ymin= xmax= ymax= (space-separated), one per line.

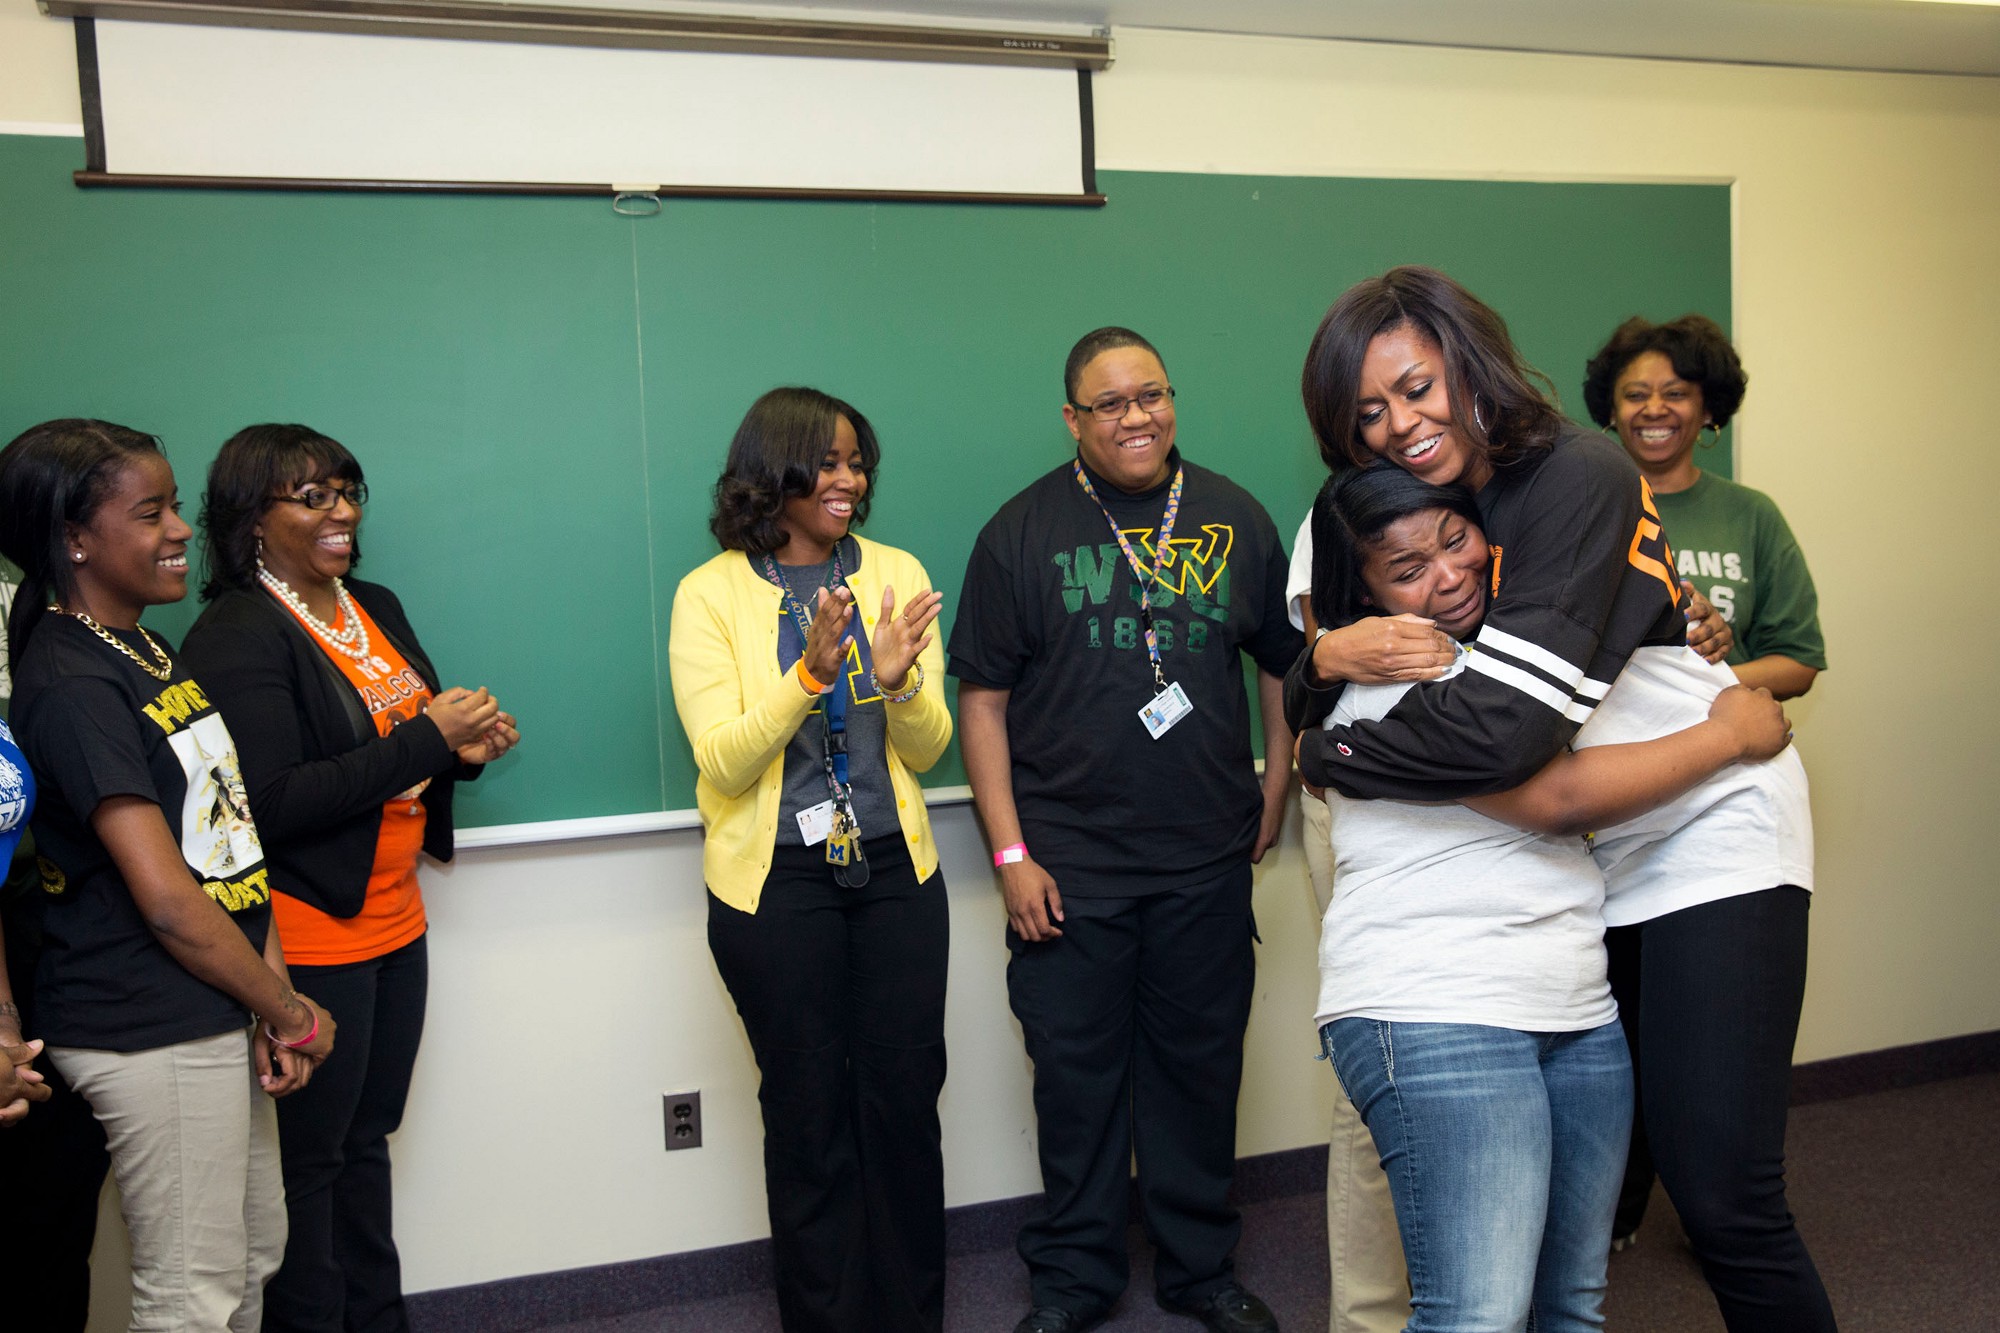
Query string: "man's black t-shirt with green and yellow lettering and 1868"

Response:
xmin=950 ymin=450 xmax=1304 ymax=897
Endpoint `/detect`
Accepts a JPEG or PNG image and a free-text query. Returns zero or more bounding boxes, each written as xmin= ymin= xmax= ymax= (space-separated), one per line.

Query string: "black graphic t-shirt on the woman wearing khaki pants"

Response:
xmin=14 ymin=614 xmax=270 ymax=1051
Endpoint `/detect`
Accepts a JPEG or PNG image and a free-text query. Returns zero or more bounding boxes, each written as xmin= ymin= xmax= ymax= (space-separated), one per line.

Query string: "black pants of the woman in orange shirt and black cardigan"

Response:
xmin=264 ymin=935 xmax=430 ymax=1333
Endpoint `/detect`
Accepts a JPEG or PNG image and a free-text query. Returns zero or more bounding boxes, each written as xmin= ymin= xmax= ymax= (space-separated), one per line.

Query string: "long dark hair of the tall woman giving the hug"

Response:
xmin=1300 ymin=264 xmax=1562 ymax=472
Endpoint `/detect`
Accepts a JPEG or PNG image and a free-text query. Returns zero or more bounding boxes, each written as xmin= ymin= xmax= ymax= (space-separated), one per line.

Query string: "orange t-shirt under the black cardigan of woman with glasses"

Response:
xmin=270 ymin=602 xmax=430 ymax=967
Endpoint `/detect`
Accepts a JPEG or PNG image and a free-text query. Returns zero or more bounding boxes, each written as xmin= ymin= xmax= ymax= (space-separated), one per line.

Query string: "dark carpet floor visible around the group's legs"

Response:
xmin=528 ymin=1075 xmax=2000 ymax=1333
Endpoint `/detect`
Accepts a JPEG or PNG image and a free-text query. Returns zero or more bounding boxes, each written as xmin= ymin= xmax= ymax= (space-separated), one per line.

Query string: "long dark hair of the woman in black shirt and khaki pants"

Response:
xmin=0 ymin=416 xmax=166 ymax=664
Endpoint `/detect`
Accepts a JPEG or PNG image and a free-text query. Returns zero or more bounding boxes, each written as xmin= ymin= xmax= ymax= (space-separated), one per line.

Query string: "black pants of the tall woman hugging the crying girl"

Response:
xmin=1604 ymin=885 xmax=1834 ymax=1333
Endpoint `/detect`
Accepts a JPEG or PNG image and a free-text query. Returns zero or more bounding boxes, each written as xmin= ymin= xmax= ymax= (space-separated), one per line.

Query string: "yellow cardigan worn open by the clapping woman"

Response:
xmin=666 ymin=536 xmax=952 ymax=913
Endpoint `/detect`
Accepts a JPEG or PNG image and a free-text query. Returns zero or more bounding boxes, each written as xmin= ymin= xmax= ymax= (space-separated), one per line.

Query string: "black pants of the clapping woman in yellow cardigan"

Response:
xmin=708 ymin=835 xmax=950 ymax=1333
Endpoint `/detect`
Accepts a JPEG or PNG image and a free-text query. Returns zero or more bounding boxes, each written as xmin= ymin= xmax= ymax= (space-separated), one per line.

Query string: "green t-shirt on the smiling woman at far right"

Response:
xmin=1654 ymin=472 xmax=1826 ymax=671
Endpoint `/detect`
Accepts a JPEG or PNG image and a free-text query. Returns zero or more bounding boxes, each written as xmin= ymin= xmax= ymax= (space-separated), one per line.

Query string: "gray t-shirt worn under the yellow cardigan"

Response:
xmin=756 ymin=538 xmax=902 ymax=847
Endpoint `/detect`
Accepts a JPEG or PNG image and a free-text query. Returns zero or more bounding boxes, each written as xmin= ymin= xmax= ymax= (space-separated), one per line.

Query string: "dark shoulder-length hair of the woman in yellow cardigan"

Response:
xmin=708 ymin=386 xmax=882 ymax=554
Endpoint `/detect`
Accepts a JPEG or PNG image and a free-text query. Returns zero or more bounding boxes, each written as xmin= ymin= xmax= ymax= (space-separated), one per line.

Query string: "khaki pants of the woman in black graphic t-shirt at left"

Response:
xmin=50 ymin=1031 xmax=286 ymax=1333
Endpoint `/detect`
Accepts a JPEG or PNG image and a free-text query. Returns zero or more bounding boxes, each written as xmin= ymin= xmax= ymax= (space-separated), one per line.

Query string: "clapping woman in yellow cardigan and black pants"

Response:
xmin=668 ymin=388 xmax=952 ymax=1333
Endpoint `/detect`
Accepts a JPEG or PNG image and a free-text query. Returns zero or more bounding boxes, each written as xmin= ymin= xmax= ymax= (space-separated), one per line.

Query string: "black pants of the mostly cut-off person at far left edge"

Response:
xmin=0 ymin=908 xmax=112 ymax=1333
